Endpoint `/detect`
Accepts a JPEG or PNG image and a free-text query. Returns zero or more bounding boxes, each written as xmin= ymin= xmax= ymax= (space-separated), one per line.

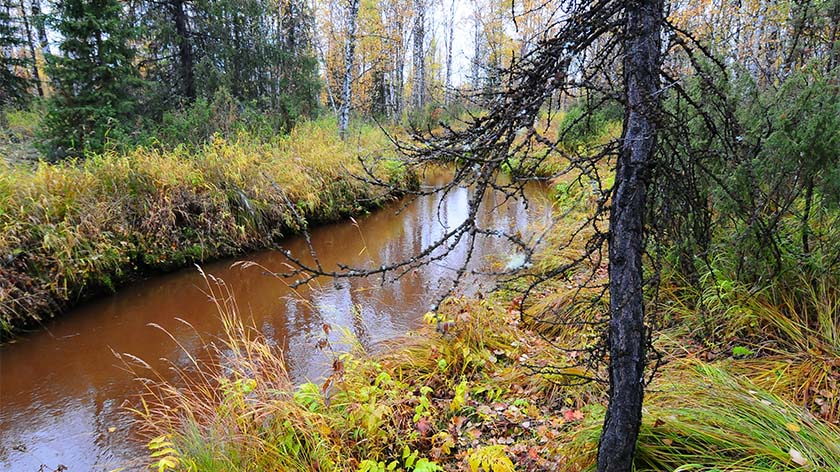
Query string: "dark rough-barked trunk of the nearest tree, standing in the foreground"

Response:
xmin=598 ymin=0 xmax=663 ymax=472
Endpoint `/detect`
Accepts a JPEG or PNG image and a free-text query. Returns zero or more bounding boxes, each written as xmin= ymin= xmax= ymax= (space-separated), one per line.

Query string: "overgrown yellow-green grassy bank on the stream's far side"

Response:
xmin=0 ymin=121 xmax=411 ymax=335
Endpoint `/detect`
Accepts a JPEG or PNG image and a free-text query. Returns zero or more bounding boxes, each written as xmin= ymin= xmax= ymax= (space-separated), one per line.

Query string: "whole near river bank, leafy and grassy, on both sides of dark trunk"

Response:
xmin=134 ymin=164 xmax=840 ymax=472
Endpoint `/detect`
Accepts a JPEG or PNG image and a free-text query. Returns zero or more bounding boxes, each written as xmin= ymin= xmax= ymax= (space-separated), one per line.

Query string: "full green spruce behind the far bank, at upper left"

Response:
xmin=44 ymin=0 xmax=141 ymax=158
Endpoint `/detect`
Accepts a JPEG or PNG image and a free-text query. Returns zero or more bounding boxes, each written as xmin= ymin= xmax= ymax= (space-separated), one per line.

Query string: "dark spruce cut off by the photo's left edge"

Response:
xmin=0 ymin=0 xmax=28 ymax=107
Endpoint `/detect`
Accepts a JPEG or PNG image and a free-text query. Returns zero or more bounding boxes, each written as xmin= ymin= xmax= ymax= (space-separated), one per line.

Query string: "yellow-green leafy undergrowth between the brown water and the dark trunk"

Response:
xmin=126 ymin=277 xmax=584 ymax=472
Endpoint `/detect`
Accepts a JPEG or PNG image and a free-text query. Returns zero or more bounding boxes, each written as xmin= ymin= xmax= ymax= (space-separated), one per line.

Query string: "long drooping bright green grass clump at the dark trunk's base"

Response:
xmin=568 ymin=361 xmax=840 ymax=472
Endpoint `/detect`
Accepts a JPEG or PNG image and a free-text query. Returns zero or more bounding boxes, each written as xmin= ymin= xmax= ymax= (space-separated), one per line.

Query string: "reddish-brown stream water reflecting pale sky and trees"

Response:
xmin=0 ymin=176 xmax=550 ymax=472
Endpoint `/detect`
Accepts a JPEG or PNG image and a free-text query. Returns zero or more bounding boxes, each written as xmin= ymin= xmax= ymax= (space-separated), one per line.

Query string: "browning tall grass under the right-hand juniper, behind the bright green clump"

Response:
xmin=663 ymin=269 xmax=840 ymax=423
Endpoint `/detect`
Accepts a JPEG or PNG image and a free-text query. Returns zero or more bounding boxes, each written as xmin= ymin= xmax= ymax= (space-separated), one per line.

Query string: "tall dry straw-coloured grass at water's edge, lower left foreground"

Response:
xmin=127 ymin=276 xmax=340 ymax=472
